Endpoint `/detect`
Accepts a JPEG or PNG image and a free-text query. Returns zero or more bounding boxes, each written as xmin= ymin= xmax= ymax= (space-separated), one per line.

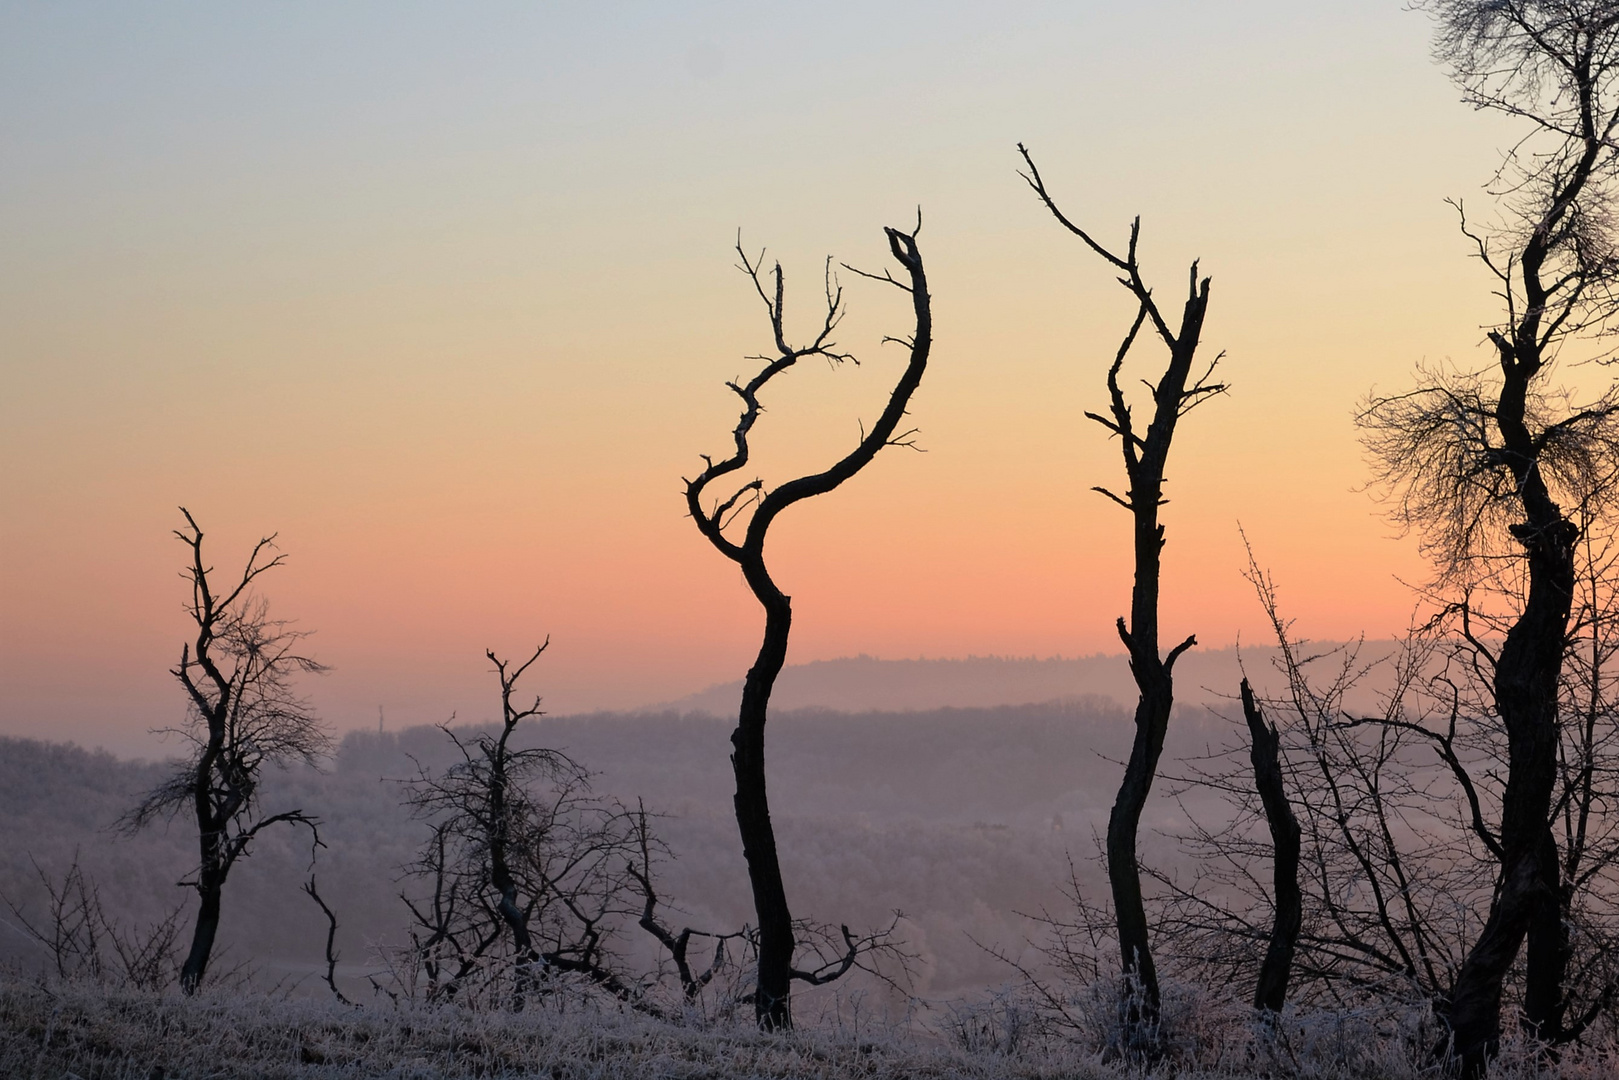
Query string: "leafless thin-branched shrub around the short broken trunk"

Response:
xmin=1158 ymin=565 xmax=1489 ymax=1007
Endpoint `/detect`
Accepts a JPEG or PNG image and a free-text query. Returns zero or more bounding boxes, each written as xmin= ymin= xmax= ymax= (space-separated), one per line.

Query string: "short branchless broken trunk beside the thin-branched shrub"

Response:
xmin=1242 ymin=678 xmax=1305 ymax=1014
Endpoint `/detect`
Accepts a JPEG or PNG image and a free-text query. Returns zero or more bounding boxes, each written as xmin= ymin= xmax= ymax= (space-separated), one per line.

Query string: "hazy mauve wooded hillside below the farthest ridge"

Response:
xmin=0 ymin=698 xmax=1226 ymax=994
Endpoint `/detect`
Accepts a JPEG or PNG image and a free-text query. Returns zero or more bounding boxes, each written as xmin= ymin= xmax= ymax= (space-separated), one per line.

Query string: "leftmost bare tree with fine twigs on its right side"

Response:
xmin=121 ymin=507 xmax=330 ymax=994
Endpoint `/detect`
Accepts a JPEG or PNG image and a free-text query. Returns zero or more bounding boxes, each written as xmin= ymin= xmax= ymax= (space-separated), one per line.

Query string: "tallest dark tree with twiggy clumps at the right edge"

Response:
xmin=1358 ymin=0 xmax=1619 ymax=1077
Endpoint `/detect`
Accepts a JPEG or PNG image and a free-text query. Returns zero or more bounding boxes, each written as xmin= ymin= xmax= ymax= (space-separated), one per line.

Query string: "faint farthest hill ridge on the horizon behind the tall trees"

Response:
xmin=649 ymin=641 xmax=1397 ymax=716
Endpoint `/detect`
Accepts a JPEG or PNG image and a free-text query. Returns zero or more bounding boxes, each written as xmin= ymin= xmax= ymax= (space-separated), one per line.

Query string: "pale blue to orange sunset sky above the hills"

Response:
xmin=0 ymin=0 xmax=1567 ymax=748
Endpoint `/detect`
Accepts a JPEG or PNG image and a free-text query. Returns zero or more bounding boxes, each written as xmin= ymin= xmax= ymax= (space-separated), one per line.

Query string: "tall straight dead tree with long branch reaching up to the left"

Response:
xmin=1018 ymin=142 xmax=1226 ymax=1054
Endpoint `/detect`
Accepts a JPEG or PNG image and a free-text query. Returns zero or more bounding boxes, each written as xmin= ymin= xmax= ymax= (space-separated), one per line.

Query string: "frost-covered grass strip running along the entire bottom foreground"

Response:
xmin=0 ymin=976 xmax=1616 ymax=1080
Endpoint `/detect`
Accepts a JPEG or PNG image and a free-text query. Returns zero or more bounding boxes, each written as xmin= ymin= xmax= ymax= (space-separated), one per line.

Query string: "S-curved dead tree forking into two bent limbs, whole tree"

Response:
xmin=686 ymin=219 xmax=933 ymax=1028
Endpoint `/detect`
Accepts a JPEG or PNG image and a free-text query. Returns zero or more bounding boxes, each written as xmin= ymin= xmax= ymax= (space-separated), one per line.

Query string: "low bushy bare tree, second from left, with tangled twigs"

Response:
xmin=403 ymin=641 xmax=644 ymax=1010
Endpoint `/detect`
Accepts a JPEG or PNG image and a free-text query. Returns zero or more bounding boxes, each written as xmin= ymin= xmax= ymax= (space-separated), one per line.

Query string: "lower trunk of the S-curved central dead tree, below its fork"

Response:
xmin=730 ymin=563 xmax=795 ymax=1030
